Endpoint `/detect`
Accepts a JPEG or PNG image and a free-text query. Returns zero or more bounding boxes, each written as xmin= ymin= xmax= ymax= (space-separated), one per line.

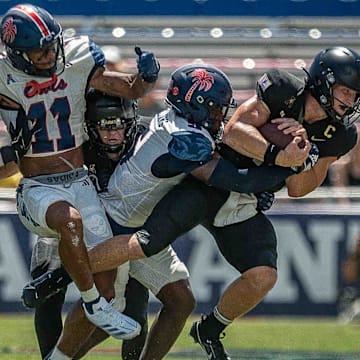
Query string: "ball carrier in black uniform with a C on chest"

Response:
xmin=188 ymin=47 xmax=360 ymax=359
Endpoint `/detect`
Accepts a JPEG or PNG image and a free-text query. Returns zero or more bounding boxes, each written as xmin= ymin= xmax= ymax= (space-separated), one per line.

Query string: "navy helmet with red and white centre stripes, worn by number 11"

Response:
xmin=1 ymin=4 xmax=65 ymax=77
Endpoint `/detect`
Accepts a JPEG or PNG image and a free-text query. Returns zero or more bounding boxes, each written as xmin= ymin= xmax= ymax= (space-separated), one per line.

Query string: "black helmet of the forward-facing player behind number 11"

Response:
xmin=85 ymin=89 xmax=139 ymax=155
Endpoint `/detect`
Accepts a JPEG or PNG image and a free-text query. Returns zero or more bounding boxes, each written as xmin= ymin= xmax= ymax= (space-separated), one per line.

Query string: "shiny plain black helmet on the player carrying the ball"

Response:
xmin=305 ymin=47 xmax=360 ymax=122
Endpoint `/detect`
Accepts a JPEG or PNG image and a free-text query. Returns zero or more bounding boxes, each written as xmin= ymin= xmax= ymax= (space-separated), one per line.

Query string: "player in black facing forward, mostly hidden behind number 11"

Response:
xmin=22 ymin=89 xmax=149 ymax=360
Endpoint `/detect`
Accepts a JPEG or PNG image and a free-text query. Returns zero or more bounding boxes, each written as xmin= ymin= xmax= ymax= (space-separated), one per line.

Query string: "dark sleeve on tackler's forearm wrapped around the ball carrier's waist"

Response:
xmin=208 ymin=159 xmax=295 ymax=193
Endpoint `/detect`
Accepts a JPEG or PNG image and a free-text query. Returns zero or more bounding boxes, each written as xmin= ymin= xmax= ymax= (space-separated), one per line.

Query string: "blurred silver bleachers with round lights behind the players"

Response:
xmin=52 ymin=16 xmax=360 ymax=102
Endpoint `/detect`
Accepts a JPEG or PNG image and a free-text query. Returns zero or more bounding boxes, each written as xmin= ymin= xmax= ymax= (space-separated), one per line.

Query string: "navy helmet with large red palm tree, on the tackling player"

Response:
xmin=165 ymin=64 xmax=236 ymax=132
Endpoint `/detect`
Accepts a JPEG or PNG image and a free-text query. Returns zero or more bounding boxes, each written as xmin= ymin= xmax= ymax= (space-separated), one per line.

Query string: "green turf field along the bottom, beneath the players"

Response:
xmin=0 ymin=315 xmax=360 ymax=360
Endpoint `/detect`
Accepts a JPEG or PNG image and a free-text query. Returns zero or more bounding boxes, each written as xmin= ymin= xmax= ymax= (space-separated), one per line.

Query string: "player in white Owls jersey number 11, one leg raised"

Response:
xmin=0 ymin=4 xmax=159 ymax=352
